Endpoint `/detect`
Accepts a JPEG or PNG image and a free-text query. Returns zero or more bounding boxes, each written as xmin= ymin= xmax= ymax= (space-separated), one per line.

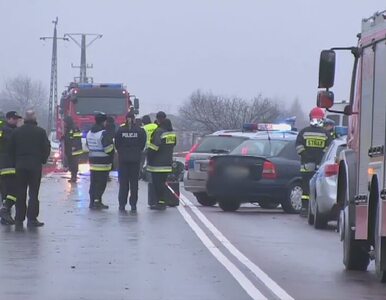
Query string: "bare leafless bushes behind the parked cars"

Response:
xmin=180 ymin=90 xmax=282 ymax=133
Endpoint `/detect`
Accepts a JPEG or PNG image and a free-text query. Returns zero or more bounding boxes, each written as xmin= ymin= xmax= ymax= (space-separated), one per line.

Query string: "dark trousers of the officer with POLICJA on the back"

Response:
xmin=118 ymin=162 xmax=140 ymax=207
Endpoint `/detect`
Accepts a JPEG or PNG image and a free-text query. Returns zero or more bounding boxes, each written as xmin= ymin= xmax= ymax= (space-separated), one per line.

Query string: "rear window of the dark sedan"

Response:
xmin=231 ymin=139 xmax=289 ymax=157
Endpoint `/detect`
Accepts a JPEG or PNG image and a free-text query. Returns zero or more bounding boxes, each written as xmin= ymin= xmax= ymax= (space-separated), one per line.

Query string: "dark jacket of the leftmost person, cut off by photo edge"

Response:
xmin=0 ymin=123 xmax=16 ymax=175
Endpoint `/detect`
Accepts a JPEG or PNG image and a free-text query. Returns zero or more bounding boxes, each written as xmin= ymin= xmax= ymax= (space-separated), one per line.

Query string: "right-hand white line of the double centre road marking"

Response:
xmin=180 ymin=193 xmax=294 ymax=300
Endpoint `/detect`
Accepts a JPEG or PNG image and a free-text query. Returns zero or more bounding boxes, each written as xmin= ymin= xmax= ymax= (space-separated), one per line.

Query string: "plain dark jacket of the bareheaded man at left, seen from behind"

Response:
xmin=9 ymin=121 xmax=51 ymax=170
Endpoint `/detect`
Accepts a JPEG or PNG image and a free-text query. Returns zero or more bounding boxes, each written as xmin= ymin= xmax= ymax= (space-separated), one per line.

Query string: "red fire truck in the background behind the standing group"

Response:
xmin=56 ymin=82 xmax=139 ymax=162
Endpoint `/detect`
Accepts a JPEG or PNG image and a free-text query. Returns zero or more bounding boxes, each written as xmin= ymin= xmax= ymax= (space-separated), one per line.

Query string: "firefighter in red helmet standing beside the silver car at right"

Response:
xmin=296 ymin=107 xmax=332 ymax=217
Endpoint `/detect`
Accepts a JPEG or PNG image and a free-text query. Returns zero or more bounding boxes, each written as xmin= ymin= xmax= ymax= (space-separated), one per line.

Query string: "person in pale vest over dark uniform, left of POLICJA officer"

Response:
xmin=86 ymin=112 xmax=114 ymax=209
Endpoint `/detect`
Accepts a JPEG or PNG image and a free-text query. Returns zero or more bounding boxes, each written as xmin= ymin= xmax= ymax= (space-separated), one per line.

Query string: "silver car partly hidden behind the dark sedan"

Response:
xmin=184 ymin=130 xmax=252 ymax=206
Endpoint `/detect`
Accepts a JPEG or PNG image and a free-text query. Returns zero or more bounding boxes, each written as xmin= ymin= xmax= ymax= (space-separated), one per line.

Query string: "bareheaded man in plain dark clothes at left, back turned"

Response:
xmin=9 ymin=110 xmax=51 ymax=227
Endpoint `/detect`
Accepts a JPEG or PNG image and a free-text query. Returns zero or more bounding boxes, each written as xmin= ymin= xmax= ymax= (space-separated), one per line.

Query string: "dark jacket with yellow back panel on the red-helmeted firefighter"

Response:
xmin=296 ymin=126 xmax=332 ymax=166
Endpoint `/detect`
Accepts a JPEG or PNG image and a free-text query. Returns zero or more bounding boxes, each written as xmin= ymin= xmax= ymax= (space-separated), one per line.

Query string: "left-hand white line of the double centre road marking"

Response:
xmin=177 ymin=205 xmax=267 ymax=300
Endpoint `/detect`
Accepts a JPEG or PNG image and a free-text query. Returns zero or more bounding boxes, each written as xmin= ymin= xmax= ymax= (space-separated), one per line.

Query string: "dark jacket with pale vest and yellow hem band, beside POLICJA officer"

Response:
xmin=86 ymin=124 xmax=114 ymax=171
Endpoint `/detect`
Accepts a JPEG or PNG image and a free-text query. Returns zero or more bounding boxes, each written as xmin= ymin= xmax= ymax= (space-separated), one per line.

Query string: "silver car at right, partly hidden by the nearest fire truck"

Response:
xmin=308 ymin=136 xmax=347 ymax=229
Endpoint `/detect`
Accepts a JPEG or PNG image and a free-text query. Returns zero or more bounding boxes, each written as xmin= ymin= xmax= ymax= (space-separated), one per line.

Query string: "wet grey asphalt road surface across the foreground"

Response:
xmin=0 ymin=174 xmax=386 ymax=300
